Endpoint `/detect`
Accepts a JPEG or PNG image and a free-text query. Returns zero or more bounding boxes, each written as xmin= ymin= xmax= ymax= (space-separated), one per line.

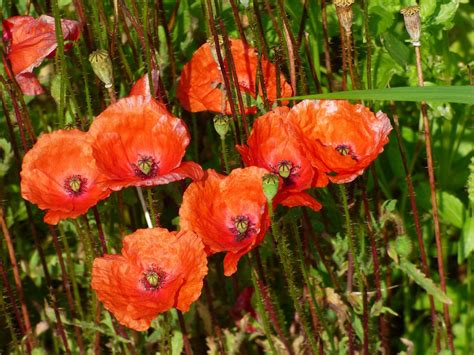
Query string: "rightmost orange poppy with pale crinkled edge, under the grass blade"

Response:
xmin=287 ymin=100 xmax=392 ymax=186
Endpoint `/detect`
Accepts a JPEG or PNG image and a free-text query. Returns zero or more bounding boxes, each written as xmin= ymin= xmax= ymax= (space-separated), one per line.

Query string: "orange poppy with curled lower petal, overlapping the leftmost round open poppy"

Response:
xmin=89 ymin=96 xmax=203 ymax=190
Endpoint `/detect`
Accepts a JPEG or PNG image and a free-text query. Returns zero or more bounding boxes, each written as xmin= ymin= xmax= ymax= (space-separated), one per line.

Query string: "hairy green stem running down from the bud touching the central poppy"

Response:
xmin=267 ymin=201 xmax=318 ymax=353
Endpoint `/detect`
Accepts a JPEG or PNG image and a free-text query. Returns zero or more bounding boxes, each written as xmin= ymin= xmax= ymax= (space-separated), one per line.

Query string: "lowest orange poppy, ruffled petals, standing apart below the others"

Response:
xmin=92 ymin=228 xmax=207 ymax=331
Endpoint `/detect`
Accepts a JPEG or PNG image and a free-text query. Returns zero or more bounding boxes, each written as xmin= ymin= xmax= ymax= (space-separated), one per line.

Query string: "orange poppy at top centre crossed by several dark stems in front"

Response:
xmin=176 ymin=39 xmax=293 ymax=114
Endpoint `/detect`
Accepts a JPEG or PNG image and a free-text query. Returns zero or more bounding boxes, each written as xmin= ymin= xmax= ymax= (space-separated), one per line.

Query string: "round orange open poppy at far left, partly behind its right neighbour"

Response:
xmin=21 ymin=129 xmax=110 ymax=224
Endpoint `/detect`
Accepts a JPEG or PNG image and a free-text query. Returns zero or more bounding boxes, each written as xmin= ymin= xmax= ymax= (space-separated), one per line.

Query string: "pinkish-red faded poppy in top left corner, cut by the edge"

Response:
xmin=2 ymin=15 xmax=80 ymax=94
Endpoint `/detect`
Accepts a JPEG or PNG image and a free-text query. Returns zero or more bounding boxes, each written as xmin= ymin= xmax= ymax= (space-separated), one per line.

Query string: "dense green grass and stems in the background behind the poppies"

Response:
xmin=0 ymin=0 xmax=474 ymax=354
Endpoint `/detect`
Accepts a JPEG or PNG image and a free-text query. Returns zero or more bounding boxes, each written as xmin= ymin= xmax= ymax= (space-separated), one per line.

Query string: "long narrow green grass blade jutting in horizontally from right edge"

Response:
xmin=279 ymin=86 xmax=474 ymax=105
